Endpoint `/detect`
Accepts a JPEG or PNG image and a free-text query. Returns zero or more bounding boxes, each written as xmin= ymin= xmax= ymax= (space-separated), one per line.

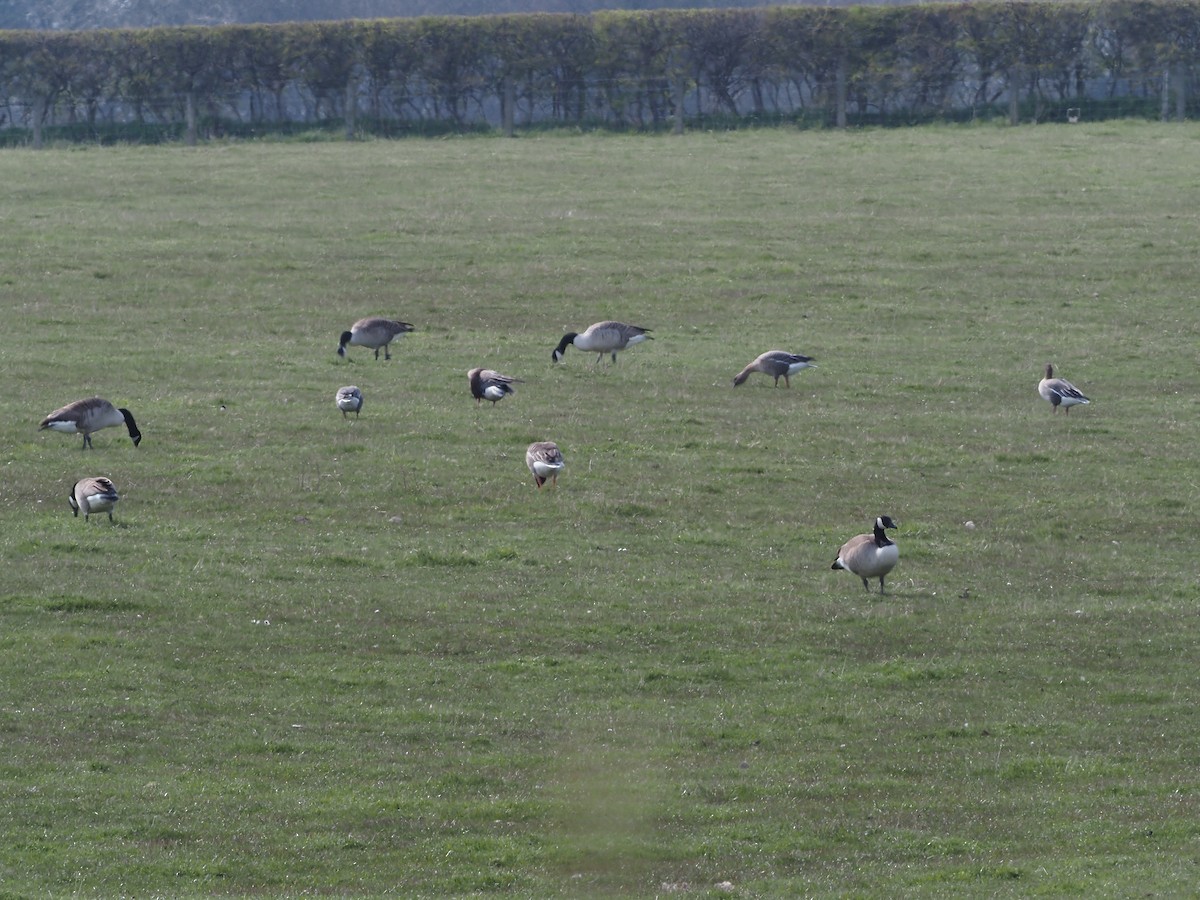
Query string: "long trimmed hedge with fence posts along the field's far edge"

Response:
xmin=0 ymin=0 xmax=1200 ymax=146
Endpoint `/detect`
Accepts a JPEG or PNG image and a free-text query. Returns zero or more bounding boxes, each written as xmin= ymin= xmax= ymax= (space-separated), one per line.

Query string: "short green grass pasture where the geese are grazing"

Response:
xmin=0 ymin=122 xmax=1200 ymax=898
